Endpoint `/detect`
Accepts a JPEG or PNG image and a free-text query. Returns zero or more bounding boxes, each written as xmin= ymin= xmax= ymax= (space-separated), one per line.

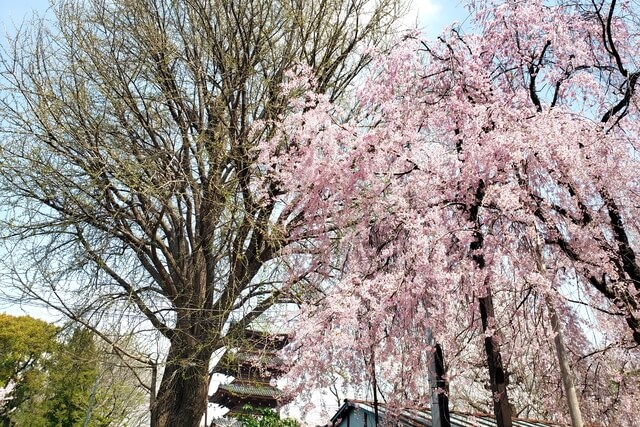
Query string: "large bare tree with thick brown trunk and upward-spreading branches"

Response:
xmin=0 ymin=0 xmax=400 ymax=426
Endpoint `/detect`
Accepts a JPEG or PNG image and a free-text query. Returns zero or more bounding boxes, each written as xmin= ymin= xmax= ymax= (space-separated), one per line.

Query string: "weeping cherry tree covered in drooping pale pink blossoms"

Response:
xmin=263 ymin=1 xmax=640 ymax=426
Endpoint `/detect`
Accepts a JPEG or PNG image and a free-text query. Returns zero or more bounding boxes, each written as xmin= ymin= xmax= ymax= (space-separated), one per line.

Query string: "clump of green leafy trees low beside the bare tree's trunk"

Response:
xmin=0 ymin=314 xmax=144 ymax=427
